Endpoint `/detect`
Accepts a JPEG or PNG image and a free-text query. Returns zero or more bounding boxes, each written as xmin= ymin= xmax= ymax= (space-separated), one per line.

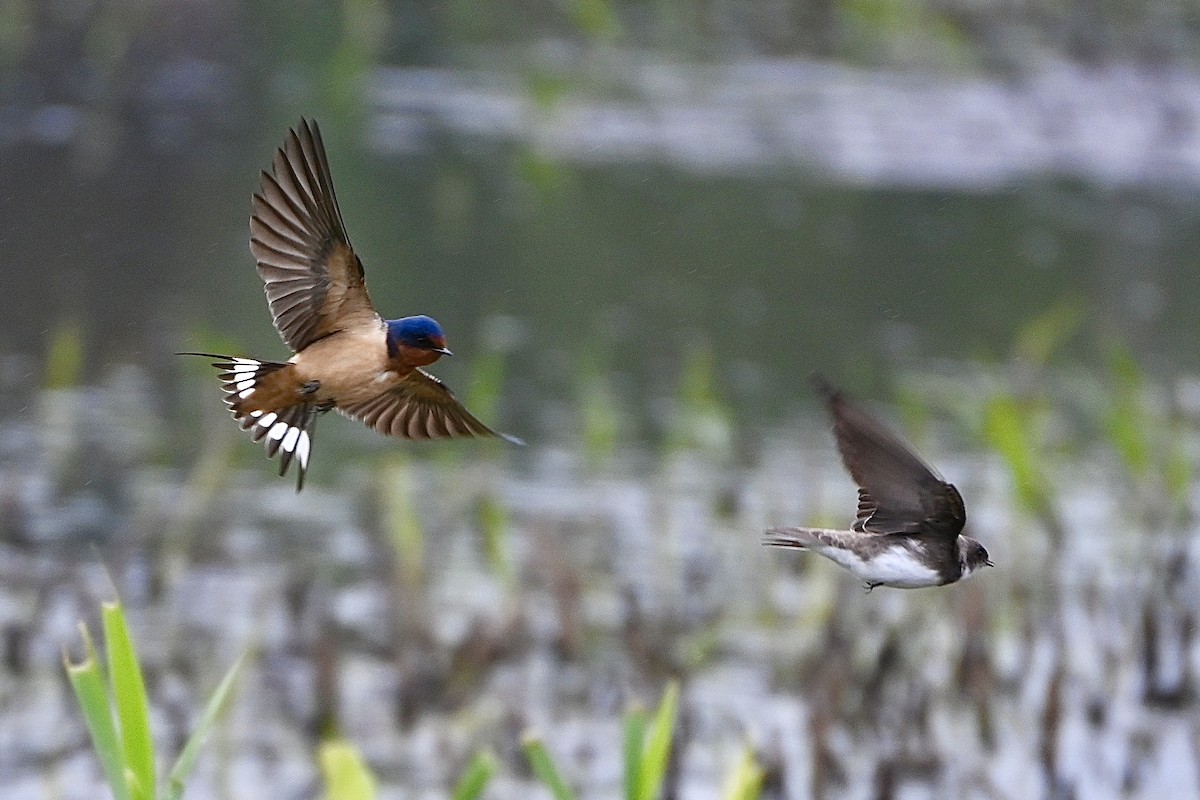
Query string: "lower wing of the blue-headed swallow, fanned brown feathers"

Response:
xmin=338 ymin=369 xmax=524 ymax=444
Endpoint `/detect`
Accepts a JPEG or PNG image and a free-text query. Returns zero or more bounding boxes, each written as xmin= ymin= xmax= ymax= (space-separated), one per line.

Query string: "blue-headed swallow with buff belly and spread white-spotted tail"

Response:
xmin=181 ymin=119 xmax=522 ymax=492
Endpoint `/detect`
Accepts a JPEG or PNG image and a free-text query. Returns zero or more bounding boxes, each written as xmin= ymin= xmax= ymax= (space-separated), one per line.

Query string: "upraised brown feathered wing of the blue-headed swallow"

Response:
xmin=250 ymin=120 xmax=378 ymax=353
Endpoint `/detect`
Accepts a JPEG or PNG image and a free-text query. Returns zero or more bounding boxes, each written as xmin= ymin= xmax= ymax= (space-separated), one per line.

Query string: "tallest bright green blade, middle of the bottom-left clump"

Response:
xmin=100 ymin=602 xmax=157 ymax=799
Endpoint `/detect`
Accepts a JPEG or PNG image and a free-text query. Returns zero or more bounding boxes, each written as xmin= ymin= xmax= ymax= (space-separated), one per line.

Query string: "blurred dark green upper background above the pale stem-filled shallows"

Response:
xmin=0 ymin=0 xmax=1200 ymax=450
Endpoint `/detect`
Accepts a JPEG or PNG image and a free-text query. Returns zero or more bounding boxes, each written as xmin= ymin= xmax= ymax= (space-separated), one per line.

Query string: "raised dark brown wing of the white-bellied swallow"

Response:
xmin=816 ymin=379 xmax=967 ymax=539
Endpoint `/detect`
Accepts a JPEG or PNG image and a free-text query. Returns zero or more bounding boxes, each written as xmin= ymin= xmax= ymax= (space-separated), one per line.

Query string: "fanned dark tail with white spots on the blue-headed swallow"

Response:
xmin=178 ymin=353 xmax=325 ymax=492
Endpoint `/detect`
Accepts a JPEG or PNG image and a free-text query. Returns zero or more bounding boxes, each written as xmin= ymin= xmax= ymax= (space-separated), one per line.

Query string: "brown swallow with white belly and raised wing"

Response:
xmin=764 ymin=378 xmax=992 ymax=591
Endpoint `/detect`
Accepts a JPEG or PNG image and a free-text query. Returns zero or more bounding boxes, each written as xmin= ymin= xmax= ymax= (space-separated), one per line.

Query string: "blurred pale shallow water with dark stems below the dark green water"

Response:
xmin=0 ymin=371 xmax=1200 ymax=800
